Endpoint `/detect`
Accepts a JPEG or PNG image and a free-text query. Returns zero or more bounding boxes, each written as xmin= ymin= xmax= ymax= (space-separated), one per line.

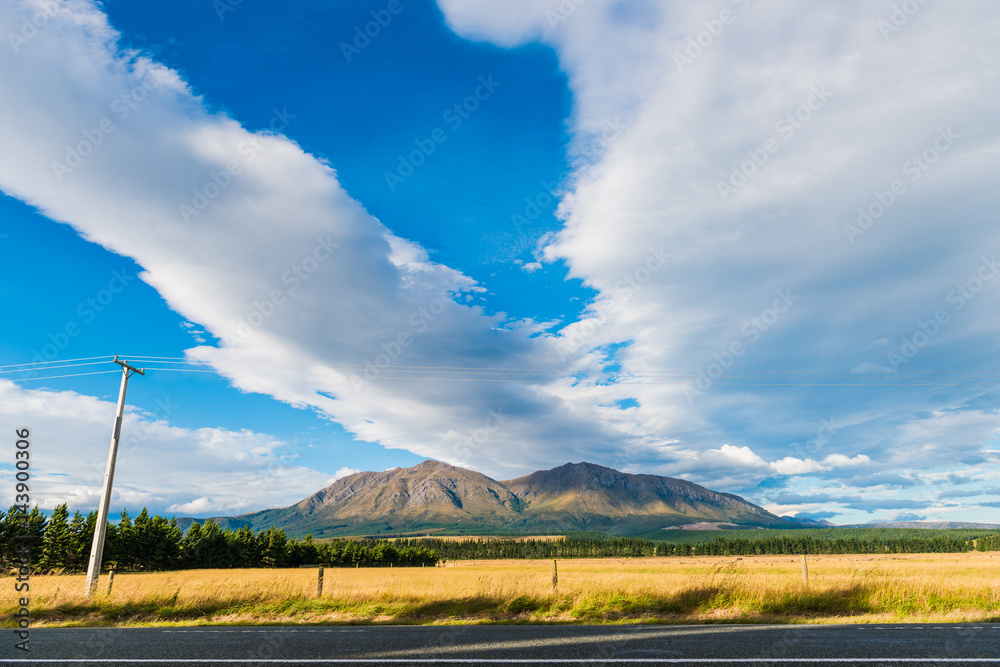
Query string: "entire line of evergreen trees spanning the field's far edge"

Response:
xmin=0 ymin=504 xmax=1000 ymax=571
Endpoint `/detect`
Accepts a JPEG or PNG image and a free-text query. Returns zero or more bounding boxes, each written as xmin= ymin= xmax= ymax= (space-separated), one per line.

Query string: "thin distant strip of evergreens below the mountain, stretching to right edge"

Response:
xmin=404 ymin=531 xmax=1000 ymax=560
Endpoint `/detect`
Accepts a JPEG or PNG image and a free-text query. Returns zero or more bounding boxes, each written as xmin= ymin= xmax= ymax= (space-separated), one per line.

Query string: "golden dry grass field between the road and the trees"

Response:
xmin=0 ymin=552 xmax=1000 ymax=627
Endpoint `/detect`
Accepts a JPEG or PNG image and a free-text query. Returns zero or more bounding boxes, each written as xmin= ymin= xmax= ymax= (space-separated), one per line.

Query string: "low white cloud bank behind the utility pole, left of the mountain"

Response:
xmin=0 ymin=380 xmax=336 ymax=514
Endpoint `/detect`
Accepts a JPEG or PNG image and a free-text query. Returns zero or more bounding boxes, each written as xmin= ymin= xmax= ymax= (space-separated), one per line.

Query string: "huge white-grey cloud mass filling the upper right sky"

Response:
xmin=439 ymin=0 xmax=1000 ymax=483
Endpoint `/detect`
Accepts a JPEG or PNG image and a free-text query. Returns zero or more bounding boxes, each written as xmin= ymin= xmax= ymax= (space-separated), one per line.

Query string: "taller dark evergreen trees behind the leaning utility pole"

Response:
xmin=0 ymin=504 xmax=438 ymax=572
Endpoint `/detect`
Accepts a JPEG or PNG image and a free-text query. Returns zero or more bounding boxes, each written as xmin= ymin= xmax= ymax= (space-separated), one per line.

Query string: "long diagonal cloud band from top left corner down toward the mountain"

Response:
xmin=0 ymin=0 xmax=640 ymax=490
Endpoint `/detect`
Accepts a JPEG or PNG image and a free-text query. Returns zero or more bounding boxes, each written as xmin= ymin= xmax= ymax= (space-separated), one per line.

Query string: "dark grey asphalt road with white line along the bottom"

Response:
xmin=0 ymin=624 xmax=1000 ymax=666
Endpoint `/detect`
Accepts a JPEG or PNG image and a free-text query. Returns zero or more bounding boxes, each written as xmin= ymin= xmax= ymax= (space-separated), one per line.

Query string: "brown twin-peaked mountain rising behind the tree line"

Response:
xmin=205 ymin=461 xmax=797 ymax=538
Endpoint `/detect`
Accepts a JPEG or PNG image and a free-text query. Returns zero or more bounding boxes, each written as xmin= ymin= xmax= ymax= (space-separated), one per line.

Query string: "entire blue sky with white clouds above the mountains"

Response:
xmin=0 ymin=0 xmax=1000 ymax=523
